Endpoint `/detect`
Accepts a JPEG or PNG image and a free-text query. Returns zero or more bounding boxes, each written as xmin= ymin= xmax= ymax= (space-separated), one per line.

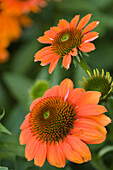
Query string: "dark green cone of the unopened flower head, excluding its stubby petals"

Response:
xmin=84 ymin=75 xmax=112 ymax=99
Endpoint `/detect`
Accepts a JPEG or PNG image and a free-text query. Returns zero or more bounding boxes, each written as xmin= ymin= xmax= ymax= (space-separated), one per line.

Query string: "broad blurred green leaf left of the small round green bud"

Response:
xmin=3 ymin=72 xmax=32 ymax=109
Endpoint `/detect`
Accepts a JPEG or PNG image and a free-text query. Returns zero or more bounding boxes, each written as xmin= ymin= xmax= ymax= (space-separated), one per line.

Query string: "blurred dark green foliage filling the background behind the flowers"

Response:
xmin=0 ymin=0 xmax=113 ymax=170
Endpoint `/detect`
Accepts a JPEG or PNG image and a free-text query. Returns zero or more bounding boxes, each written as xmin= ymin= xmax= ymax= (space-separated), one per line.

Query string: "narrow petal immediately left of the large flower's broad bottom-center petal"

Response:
xmin=34 ymin=143 xmax=47 ymax=167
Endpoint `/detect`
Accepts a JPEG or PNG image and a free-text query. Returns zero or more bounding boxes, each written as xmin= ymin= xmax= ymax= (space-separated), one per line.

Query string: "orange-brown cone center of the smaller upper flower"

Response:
xmin=52 ymin=28 xmax=83 ymax=56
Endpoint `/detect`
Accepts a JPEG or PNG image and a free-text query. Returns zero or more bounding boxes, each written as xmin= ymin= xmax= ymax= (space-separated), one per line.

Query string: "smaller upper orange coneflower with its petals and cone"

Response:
xmin=34 ymin=14 xmax=99 ymax=74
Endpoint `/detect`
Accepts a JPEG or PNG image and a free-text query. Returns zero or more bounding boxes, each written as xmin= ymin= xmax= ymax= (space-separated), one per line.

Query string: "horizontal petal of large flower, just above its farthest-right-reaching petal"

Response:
xmin=76 ymin=104 xmax=107 ymax=116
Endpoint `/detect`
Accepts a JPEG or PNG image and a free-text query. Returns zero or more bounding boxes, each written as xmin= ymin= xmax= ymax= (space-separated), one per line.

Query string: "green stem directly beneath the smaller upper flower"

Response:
xmin=76 ymin=54 xmax=93 ymax=74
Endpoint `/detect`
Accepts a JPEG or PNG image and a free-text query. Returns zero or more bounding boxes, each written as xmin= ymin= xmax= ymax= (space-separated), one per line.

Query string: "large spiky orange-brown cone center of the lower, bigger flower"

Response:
xmin=29 ymin=97 xmax=76 ymax=142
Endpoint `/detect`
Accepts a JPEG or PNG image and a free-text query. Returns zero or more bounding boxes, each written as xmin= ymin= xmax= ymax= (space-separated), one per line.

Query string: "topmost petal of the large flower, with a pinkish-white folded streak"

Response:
xmin=60 ymin=78 xmax=73 ymax=101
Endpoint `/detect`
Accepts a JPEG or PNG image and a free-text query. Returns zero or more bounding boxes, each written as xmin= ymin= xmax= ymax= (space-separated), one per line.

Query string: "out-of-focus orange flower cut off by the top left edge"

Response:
xmin=2 ymin=0 xmax=47 ymax=15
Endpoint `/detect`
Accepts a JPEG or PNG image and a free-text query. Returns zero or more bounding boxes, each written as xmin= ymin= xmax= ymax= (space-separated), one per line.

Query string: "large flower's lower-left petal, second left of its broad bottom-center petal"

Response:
xmin=25 ymin=137 xmax=40 ymax=161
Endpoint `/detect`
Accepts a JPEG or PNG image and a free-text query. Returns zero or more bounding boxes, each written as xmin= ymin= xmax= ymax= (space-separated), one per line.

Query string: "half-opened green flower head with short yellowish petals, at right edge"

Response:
xmin=80 ymin=69 xmax=113 ymax=100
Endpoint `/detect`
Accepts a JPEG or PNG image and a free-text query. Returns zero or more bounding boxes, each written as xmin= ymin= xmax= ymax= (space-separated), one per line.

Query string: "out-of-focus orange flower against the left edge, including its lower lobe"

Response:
xmin=0 ymin=11 xmax=32 ymax=63
